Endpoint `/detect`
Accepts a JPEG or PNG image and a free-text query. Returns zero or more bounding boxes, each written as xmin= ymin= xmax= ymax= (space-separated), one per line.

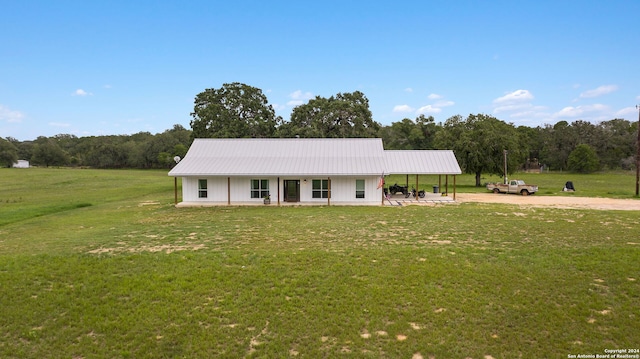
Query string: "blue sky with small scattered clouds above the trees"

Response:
xmin=0 ymin=0 xmax=640 ymax=140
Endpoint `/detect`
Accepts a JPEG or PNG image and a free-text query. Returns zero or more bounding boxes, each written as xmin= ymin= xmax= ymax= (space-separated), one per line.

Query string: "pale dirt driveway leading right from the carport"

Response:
xmin=456 ymin=193 xmax=640 ymax=211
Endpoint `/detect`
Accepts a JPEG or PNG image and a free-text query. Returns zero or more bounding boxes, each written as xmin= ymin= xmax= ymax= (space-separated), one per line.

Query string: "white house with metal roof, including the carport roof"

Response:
xmin=169 ymin=138 xmax=461 ymax=206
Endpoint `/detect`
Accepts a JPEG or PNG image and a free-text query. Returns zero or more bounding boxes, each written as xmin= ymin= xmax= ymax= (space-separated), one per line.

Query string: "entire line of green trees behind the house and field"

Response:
xmin=0 ymin=82 xmax=638 ymax=185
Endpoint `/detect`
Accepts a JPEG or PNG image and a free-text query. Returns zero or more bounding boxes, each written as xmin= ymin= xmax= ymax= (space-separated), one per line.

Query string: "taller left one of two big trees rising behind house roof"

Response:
xmin=191 ymin=82 xmax=280 ymax=138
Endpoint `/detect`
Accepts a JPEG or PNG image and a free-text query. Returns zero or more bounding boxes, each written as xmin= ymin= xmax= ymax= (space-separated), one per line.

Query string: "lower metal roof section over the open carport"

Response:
xmin=384 ymin=150 xmax=462 ymax=175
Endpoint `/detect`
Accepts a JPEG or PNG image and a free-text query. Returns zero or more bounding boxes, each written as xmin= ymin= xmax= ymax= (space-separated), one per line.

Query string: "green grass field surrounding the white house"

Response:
xmin=0 ymin=169 xmax=640 ymax=358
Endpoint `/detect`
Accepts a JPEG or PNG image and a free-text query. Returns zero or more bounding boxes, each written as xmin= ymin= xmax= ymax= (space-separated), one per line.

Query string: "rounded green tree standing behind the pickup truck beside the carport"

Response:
xmin=436 ymin=114 xmax=526 ymax=187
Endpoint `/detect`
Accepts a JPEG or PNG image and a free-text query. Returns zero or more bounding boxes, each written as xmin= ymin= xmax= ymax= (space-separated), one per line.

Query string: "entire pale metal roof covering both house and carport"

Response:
xmin=169 ymin=138 xmax=461 ymax=177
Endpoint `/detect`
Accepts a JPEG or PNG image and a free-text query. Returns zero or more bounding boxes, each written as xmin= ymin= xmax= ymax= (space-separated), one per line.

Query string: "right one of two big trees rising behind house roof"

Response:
xmin=280 ymin=91 xmax=380 ymax=138
